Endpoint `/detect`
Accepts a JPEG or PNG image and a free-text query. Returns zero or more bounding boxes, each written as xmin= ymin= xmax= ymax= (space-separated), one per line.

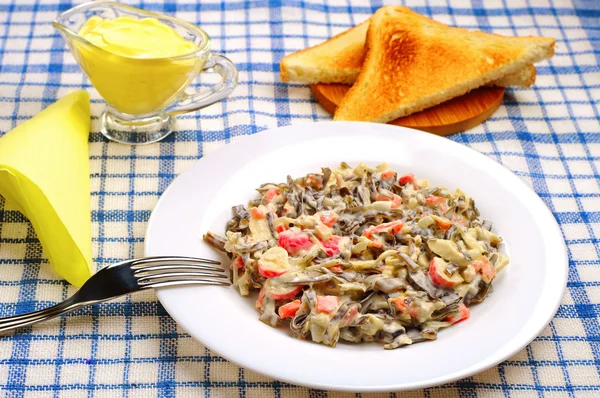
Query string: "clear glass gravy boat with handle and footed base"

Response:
xmin=52 ymin=1 xmax=237 ymax=144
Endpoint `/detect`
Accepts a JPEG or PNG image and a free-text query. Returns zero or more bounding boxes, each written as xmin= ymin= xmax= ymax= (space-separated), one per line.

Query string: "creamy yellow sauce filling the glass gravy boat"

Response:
xmin=74 ymin=16 xmax=206 ymax=115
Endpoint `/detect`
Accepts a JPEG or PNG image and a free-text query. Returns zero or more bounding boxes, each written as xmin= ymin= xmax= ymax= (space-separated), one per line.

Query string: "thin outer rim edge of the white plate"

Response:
xmin=144 ymin=121 xmax=569 ymax=392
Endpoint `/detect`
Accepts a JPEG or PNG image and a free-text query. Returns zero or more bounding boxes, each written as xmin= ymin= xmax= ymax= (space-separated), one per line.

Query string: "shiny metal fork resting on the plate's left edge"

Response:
xmin=0 ymin=256 xmax=230 ymax=332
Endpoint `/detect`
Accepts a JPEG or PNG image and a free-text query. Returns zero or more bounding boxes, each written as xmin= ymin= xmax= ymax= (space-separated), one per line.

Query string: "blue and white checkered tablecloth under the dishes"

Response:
xmin=0 ymin=0 xmax=600 ymax=398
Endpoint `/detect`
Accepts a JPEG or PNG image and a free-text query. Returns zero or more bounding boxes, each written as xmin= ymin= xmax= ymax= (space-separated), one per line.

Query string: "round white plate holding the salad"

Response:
xmin=146 ymin=122 xmax=568 ymax=392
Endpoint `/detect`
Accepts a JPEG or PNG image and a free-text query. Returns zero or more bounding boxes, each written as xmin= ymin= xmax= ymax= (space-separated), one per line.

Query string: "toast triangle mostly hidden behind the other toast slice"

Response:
xmin=280 ymin=20 xmax=536 ymax=87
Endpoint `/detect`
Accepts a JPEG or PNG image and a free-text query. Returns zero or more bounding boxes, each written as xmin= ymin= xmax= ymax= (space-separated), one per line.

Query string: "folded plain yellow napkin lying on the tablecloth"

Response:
xmin=0 ymin=91 xmax=92 ymax=286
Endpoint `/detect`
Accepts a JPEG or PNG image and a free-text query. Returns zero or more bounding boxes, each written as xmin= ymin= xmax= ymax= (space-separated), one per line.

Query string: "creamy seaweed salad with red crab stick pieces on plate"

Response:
xmin=204 ymin=163 xmax=509 ymax=349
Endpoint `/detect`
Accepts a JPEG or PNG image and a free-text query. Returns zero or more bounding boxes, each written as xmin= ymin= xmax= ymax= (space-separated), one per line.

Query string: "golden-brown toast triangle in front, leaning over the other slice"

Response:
xmin=334 ymin=6 xmax=555 ymax=123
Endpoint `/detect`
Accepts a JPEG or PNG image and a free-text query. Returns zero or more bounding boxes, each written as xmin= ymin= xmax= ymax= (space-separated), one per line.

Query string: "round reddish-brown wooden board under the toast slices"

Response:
xmin=310 ymin=83 xmax=504 ymax=136
